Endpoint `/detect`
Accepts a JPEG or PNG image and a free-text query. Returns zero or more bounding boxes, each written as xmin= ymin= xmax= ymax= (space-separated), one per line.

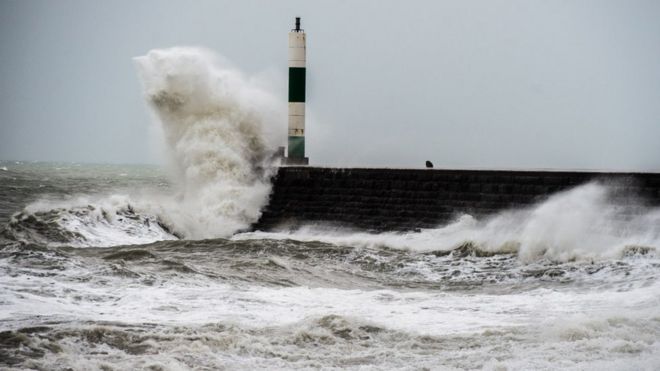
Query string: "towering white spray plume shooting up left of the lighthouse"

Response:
xmin=135 ymin=47 xmax=284 ymax=239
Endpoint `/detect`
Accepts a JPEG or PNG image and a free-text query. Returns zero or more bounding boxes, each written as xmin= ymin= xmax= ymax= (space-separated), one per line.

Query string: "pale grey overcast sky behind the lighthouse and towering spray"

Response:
xmin=0 ymin=0 xmax=660 ymax=170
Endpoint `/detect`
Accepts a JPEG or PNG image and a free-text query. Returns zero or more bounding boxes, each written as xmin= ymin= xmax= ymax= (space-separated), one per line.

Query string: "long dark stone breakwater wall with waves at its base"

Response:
xmin=253 ymin=167 xmax=660 ymax=231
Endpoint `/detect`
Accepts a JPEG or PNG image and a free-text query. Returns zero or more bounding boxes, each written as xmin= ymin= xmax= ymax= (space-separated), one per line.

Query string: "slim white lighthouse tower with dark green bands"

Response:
xmin=284 ymin=17 xmax=309 ymax=165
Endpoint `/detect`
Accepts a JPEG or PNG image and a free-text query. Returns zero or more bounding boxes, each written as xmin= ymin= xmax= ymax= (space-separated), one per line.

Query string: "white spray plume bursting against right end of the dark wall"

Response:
xmin=466 ymin=182 xmax=660 ymax=262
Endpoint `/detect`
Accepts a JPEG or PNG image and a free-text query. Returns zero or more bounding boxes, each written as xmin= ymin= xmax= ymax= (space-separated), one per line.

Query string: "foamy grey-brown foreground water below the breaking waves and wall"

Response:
xmin=0 ymin=231 xmax=660 ymax=369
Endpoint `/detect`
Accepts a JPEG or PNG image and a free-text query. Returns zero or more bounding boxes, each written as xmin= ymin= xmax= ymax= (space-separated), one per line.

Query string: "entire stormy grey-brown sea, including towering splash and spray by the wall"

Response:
xmin=0 ymin=48 xmax=660 ymax=370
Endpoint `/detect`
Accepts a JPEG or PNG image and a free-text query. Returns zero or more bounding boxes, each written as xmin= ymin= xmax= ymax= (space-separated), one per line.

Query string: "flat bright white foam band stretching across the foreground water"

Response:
xmin=0 ymin=250 xmax=660 ymax=336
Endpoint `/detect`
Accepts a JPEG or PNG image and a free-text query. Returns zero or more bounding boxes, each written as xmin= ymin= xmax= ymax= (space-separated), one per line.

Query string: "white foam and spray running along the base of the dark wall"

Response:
xmin=240 ymin=183 xmax=660 ymax=262
